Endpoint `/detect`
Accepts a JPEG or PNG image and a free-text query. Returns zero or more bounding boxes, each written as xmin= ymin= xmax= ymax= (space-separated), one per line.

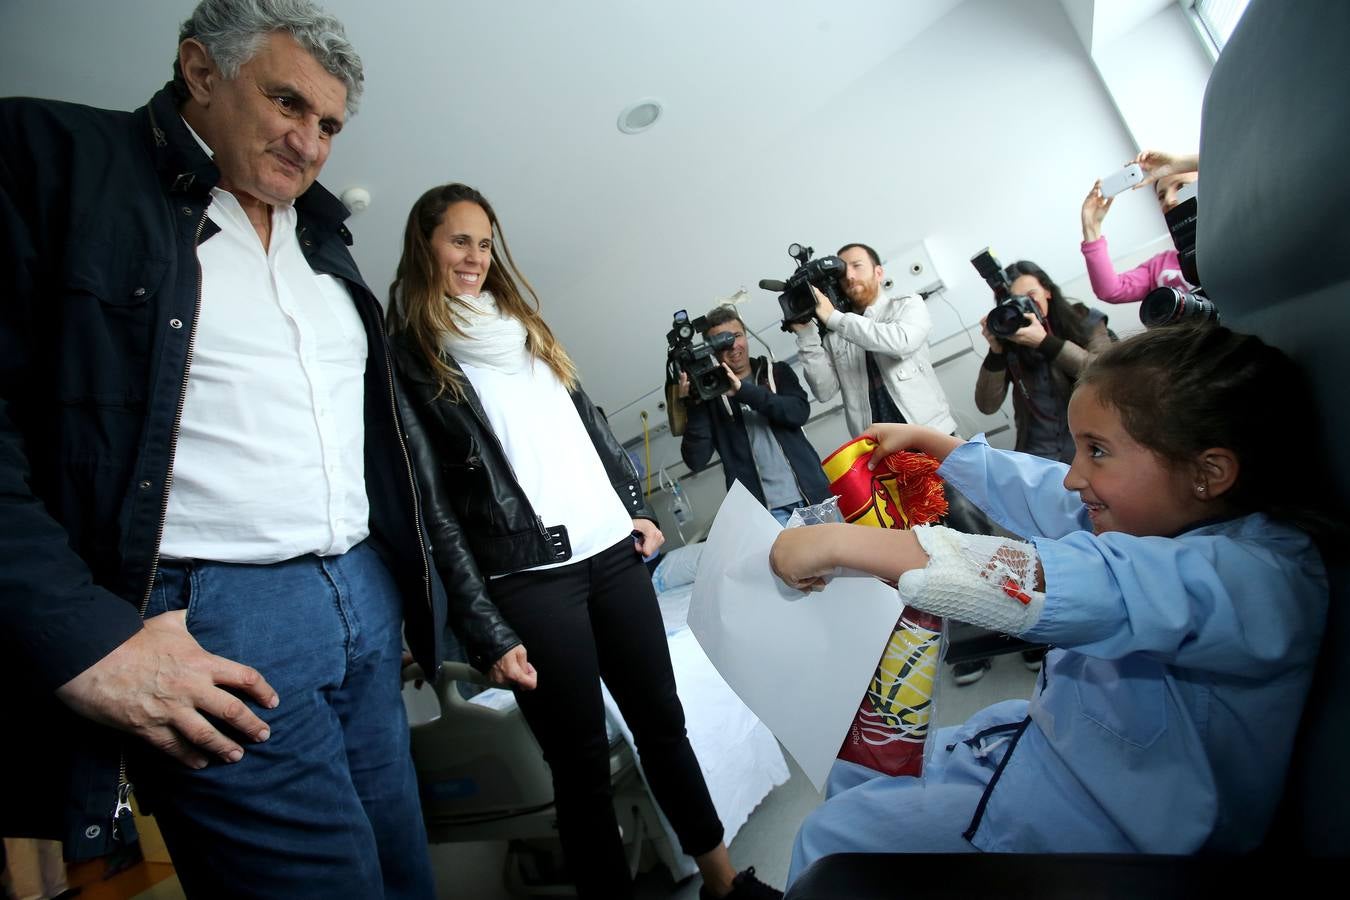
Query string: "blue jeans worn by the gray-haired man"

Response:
xmin=131 ymin=544 xmax=435 ymax=897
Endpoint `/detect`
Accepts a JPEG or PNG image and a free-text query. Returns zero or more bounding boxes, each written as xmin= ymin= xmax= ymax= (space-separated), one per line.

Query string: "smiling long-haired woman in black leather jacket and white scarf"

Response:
xmin=389 ymin=184 xmax=780 ymax=897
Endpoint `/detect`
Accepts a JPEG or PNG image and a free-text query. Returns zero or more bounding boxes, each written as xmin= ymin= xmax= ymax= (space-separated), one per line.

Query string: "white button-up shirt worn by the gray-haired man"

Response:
xmin=159 ymin=121 xmax=369 ymax=563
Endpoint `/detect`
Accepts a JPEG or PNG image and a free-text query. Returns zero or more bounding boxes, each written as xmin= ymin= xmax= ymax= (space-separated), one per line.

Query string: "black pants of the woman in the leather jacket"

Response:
xmin=490 ymin=538 xmax=722 ymax=897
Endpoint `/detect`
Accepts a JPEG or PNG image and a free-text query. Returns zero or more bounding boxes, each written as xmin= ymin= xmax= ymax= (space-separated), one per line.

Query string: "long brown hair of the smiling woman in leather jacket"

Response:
xmin=386 ymin=184 xmax=576 ymax=402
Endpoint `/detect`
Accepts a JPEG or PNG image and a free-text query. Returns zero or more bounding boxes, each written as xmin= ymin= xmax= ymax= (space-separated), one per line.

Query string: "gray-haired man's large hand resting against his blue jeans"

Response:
xmin=57 ymin=610 xmax=278 ymax=769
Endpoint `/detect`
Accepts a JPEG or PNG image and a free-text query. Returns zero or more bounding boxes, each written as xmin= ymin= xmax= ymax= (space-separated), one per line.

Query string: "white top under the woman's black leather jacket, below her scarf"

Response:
xmin=458 ymin=345 xmax=633 ymax=569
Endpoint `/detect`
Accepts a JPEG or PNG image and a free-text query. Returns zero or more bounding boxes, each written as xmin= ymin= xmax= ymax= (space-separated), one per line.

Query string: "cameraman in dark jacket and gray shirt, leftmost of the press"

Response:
xmin=679 ymin=306 xmax=830 ymax=525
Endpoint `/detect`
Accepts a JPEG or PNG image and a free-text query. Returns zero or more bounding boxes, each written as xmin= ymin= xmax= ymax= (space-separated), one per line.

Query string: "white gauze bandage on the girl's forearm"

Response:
xmin=898 ymin=525 xmax=1045 ymax=634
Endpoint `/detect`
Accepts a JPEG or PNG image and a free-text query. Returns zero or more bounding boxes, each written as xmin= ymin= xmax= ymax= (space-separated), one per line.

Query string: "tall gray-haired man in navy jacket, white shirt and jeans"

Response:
xmin=0 ymin=0 xmax=444 ymax=897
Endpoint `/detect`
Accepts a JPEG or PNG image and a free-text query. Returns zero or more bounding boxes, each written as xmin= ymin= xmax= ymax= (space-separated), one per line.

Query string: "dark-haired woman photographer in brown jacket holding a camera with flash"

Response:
xmin=975 ymin=260 xmax=1114 ymax=463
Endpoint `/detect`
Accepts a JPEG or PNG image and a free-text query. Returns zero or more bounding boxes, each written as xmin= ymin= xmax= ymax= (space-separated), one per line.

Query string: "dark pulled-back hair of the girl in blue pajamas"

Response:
xmin=1079 ymin=325 xmax=1341 ymax=540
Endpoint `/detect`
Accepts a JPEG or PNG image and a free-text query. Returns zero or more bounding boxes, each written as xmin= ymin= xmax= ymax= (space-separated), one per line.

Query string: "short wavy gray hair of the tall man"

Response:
xmin=173 ymin=0 xmax=366 ymax=115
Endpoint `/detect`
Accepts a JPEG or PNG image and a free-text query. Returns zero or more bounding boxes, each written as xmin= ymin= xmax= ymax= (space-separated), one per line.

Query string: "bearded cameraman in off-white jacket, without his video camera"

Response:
xmin=792 ymin=243 xmax=956 ymax=434
